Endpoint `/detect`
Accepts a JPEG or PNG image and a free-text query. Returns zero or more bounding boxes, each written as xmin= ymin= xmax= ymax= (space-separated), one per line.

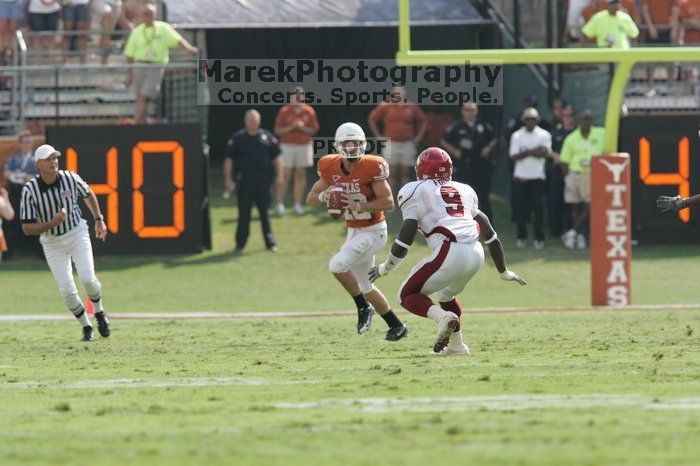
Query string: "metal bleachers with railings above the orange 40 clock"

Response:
xmin=0 ymin=30 xmax=197 ymax=132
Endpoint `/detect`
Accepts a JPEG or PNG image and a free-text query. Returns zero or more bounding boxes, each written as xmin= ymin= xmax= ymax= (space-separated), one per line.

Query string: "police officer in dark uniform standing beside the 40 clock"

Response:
xmin=224 ymin=109 xmax=284 ymax=254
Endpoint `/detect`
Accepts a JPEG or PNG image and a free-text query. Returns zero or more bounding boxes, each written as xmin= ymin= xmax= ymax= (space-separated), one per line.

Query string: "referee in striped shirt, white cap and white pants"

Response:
xmin=20 ymin=144 xmax=110 ymax=341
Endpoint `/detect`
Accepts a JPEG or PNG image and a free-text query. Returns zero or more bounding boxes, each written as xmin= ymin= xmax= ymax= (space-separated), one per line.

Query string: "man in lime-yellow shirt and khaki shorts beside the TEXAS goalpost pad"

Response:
xmin=559 ymin=110 xmax=605 ymax=249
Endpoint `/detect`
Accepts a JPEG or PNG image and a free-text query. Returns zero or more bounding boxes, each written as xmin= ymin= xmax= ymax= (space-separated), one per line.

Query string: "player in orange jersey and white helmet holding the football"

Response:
xmin=306 ymin=123 xmax=408 ymax=341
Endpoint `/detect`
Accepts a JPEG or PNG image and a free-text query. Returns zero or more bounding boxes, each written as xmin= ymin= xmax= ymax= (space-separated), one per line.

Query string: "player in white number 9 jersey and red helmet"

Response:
xmin=369 ymin=147 xmax=526 ymax=355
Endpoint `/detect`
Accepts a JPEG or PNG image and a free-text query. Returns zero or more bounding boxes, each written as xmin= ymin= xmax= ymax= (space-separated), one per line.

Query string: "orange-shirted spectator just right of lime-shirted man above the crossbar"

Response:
xmin=642 ymin=0 xmax=678 ymax=97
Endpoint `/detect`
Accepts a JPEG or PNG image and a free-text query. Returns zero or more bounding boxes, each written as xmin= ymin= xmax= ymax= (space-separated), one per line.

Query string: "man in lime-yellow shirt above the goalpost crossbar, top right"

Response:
xmin=581 ymin=0 xmax=639 ymax=49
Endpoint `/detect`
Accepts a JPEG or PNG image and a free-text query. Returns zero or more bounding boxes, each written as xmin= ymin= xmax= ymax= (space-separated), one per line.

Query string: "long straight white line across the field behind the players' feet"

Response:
xmin=0 ymin=304 xmax=700 ymax=322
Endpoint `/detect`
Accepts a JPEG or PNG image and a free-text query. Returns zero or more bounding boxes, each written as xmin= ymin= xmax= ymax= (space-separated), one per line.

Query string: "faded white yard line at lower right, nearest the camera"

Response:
xmin=273 ymin=394 xmax=700 ymax=413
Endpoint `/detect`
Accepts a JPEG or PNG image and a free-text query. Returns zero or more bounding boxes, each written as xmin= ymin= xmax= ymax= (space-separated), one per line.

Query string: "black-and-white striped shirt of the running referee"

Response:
xmin=20 ymin=170 xmax=90 ymax=236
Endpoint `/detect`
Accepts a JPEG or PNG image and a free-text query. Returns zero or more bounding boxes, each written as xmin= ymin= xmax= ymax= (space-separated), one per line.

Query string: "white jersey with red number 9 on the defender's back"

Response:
xmin=399 ymin=179 xmax=479 ymax=249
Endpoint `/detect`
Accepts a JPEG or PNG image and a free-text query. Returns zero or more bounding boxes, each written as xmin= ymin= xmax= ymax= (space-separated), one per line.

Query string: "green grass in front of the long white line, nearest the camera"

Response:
xmin=0 ymin=310 xmax=700 ymax=466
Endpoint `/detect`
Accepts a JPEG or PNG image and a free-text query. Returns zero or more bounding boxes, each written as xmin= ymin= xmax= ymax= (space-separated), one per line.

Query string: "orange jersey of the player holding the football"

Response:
xmin=318 ymin=154 xmax=389 ymax=228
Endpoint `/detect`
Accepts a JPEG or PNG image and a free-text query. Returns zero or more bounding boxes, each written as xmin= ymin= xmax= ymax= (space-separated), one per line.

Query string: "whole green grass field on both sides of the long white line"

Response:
xmin=0 ymin=173 xmax=700 ymax=466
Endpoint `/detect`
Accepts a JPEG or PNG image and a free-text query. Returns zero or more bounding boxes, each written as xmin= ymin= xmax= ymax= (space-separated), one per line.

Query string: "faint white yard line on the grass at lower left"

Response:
xmin=0 ymin=377 xmax=316 ymax=389
